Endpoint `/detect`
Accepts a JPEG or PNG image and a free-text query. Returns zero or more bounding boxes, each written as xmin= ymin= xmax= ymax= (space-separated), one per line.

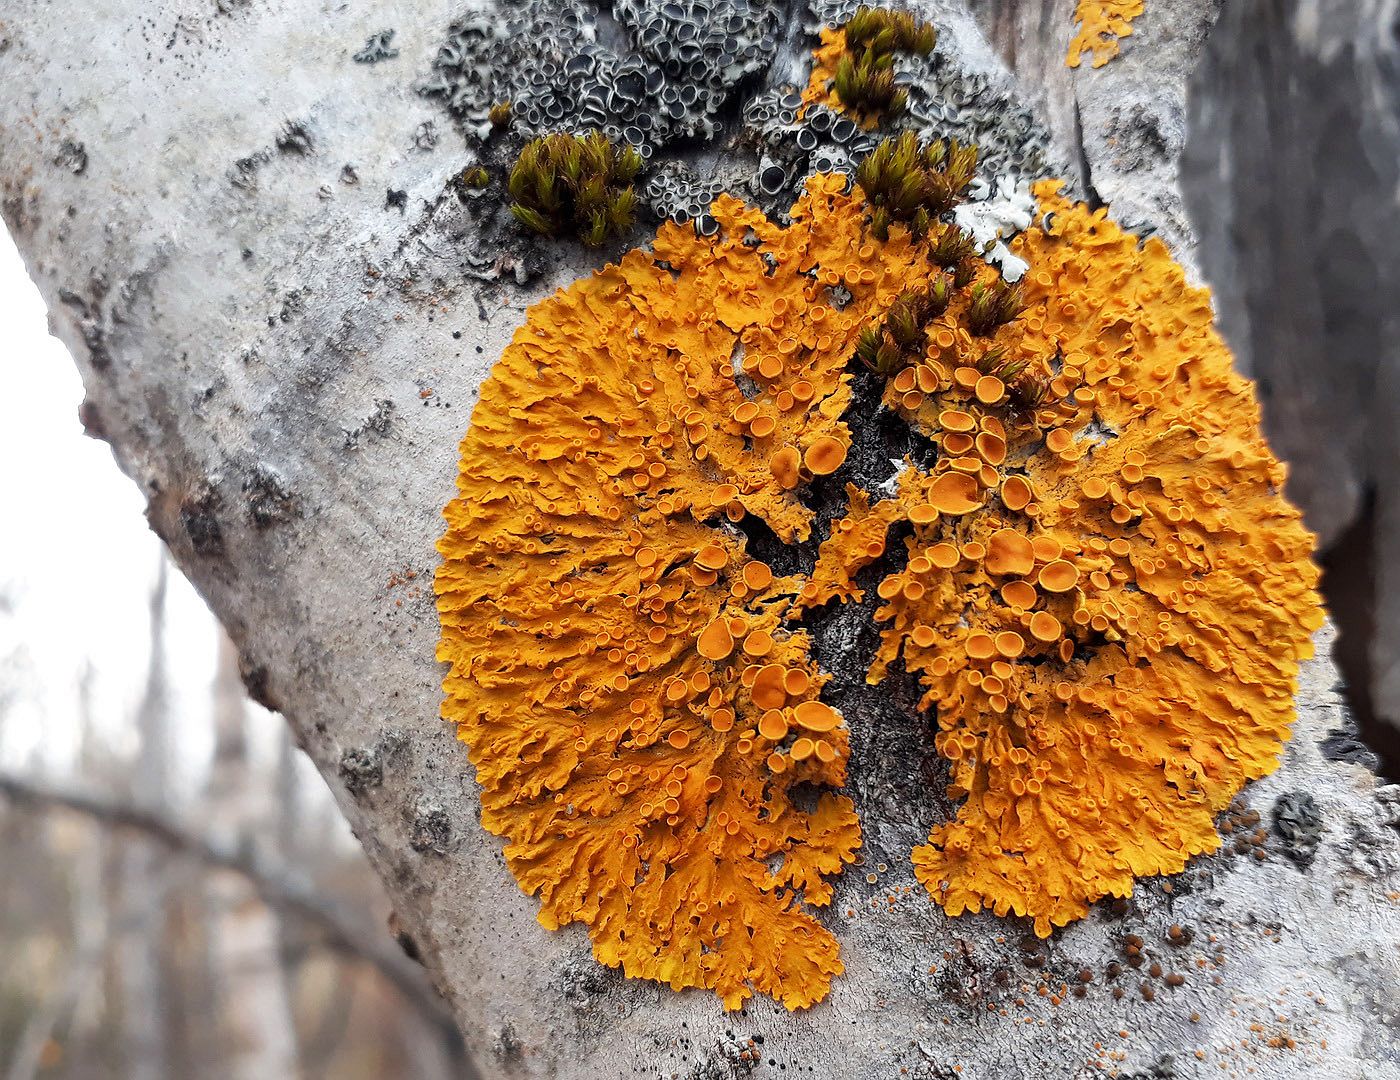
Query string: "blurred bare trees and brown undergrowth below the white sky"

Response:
xmin=0 ymin=562 xmax=469 ymax=1080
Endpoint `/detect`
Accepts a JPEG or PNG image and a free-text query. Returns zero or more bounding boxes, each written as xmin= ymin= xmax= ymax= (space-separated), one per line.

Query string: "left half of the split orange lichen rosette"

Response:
xmin=437 ymin=178 xmax=957 ymax=1009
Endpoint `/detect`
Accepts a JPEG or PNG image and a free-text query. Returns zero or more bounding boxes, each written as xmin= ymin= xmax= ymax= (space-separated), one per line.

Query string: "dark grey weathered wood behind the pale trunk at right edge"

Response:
xmin=1183 ymin=0 xmax=1400 ymax=776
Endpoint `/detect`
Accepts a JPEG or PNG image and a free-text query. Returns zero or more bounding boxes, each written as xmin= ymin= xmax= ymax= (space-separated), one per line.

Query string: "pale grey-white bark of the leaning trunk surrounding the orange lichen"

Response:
xmin=0 ymin=0 xmax=1400 ymax=1080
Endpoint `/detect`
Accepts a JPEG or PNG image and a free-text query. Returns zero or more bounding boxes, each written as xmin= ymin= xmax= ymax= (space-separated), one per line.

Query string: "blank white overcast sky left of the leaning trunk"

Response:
xmin=0 ymin=227 xmax=218 ymax=795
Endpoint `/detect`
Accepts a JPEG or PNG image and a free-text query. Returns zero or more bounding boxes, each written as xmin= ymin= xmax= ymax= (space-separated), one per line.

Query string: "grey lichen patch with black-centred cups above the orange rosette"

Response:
xmin=420 ymin=0 xmax=1058 ymax=241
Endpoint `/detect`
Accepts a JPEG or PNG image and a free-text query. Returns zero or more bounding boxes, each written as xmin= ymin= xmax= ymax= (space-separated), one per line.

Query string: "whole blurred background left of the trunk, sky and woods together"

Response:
xmin=0 ymin=231 xmax=465 ymax=1080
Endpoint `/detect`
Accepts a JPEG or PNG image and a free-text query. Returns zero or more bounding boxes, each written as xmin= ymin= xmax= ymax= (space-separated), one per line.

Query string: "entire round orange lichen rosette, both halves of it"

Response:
xmin=437 ymin=156 xmax=1322 ymax=1009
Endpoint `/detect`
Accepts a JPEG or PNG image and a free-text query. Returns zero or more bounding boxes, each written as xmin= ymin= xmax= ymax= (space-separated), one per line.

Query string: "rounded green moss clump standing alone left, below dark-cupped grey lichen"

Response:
xmin=507 ymin=132 xmax=641 ymax=248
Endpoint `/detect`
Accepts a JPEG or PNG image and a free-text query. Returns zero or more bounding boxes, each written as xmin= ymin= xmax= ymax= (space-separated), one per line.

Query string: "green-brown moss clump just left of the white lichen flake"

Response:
xmin=855 ymin=132 xmax=977 ymax=242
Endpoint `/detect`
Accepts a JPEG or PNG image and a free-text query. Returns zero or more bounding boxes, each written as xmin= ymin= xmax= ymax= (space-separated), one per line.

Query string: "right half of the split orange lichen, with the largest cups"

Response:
xmin=801 ymin=184 xmax=1322 ymax=934
